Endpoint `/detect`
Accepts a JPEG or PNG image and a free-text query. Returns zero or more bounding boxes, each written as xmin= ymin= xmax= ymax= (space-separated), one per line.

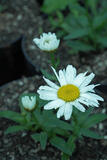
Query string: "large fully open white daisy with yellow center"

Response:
xmin=37 ymin=65 xmax=103 ymax=120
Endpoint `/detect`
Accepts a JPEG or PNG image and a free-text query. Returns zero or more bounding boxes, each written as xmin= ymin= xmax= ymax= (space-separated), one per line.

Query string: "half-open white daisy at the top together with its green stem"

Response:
xmin=33 ymin=32 xmax=60 ymax=68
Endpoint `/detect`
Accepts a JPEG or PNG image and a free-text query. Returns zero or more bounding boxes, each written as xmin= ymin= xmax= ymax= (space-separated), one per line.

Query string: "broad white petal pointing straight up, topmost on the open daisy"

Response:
xmin=66 ymin=65 xmax=76 ymax=84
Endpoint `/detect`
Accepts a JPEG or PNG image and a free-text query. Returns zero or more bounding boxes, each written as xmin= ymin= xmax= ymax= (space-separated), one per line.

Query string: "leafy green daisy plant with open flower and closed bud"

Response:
xmin=0 ymin=65 xmax=107 ymax=160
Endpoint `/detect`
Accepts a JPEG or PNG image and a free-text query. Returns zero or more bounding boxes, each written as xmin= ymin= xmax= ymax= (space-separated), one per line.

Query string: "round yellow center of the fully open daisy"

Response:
xmin=57 ymin=84 xmax=80 ymax=102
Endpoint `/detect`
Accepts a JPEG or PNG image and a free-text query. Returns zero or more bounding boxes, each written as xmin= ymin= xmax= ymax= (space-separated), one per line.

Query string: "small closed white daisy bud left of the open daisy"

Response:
xmin=21 ymin=95 xmax=36 ymax=111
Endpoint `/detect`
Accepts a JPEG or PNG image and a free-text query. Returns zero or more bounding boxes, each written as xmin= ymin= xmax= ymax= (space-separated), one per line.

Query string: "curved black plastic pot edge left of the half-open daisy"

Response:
xmin=21 ymin=37 xmax=41 ymax=75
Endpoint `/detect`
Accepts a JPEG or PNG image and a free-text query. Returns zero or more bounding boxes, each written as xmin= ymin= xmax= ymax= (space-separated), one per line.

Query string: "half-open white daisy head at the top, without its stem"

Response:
xmin=33 ymin=32 xmax=60 ymax=52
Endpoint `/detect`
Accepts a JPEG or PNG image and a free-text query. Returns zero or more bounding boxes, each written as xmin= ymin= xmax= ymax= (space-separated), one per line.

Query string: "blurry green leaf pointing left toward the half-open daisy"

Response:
xmin=64 ymin=28 xmax=89 ymax=40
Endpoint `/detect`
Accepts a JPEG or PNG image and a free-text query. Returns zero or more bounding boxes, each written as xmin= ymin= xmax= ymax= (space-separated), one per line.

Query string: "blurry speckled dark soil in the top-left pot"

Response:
xmin=0 ymin=0 xmax=42 ymax=46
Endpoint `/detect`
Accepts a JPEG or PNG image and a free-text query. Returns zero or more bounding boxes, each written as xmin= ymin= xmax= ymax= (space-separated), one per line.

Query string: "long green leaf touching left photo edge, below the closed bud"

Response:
xmin=0 ymin=111 xmax=25 ymax=123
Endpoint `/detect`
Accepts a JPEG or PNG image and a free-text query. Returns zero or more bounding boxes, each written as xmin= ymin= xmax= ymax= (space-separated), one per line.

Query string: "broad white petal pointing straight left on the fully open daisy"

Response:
xmin=37 ymin=90 xmax=57 ymax=100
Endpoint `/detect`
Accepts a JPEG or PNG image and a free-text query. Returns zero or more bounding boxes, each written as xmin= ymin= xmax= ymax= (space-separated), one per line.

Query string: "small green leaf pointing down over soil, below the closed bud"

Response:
xmin=31 ymin=132 xmax=48 ymax=150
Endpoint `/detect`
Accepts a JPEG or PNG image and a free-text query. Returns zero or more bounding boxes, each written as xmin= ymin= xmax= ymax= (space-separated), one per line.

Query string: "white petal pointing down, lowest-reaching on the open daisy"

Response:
xmin=64 ymin=103 xmax=73 ymax=120
